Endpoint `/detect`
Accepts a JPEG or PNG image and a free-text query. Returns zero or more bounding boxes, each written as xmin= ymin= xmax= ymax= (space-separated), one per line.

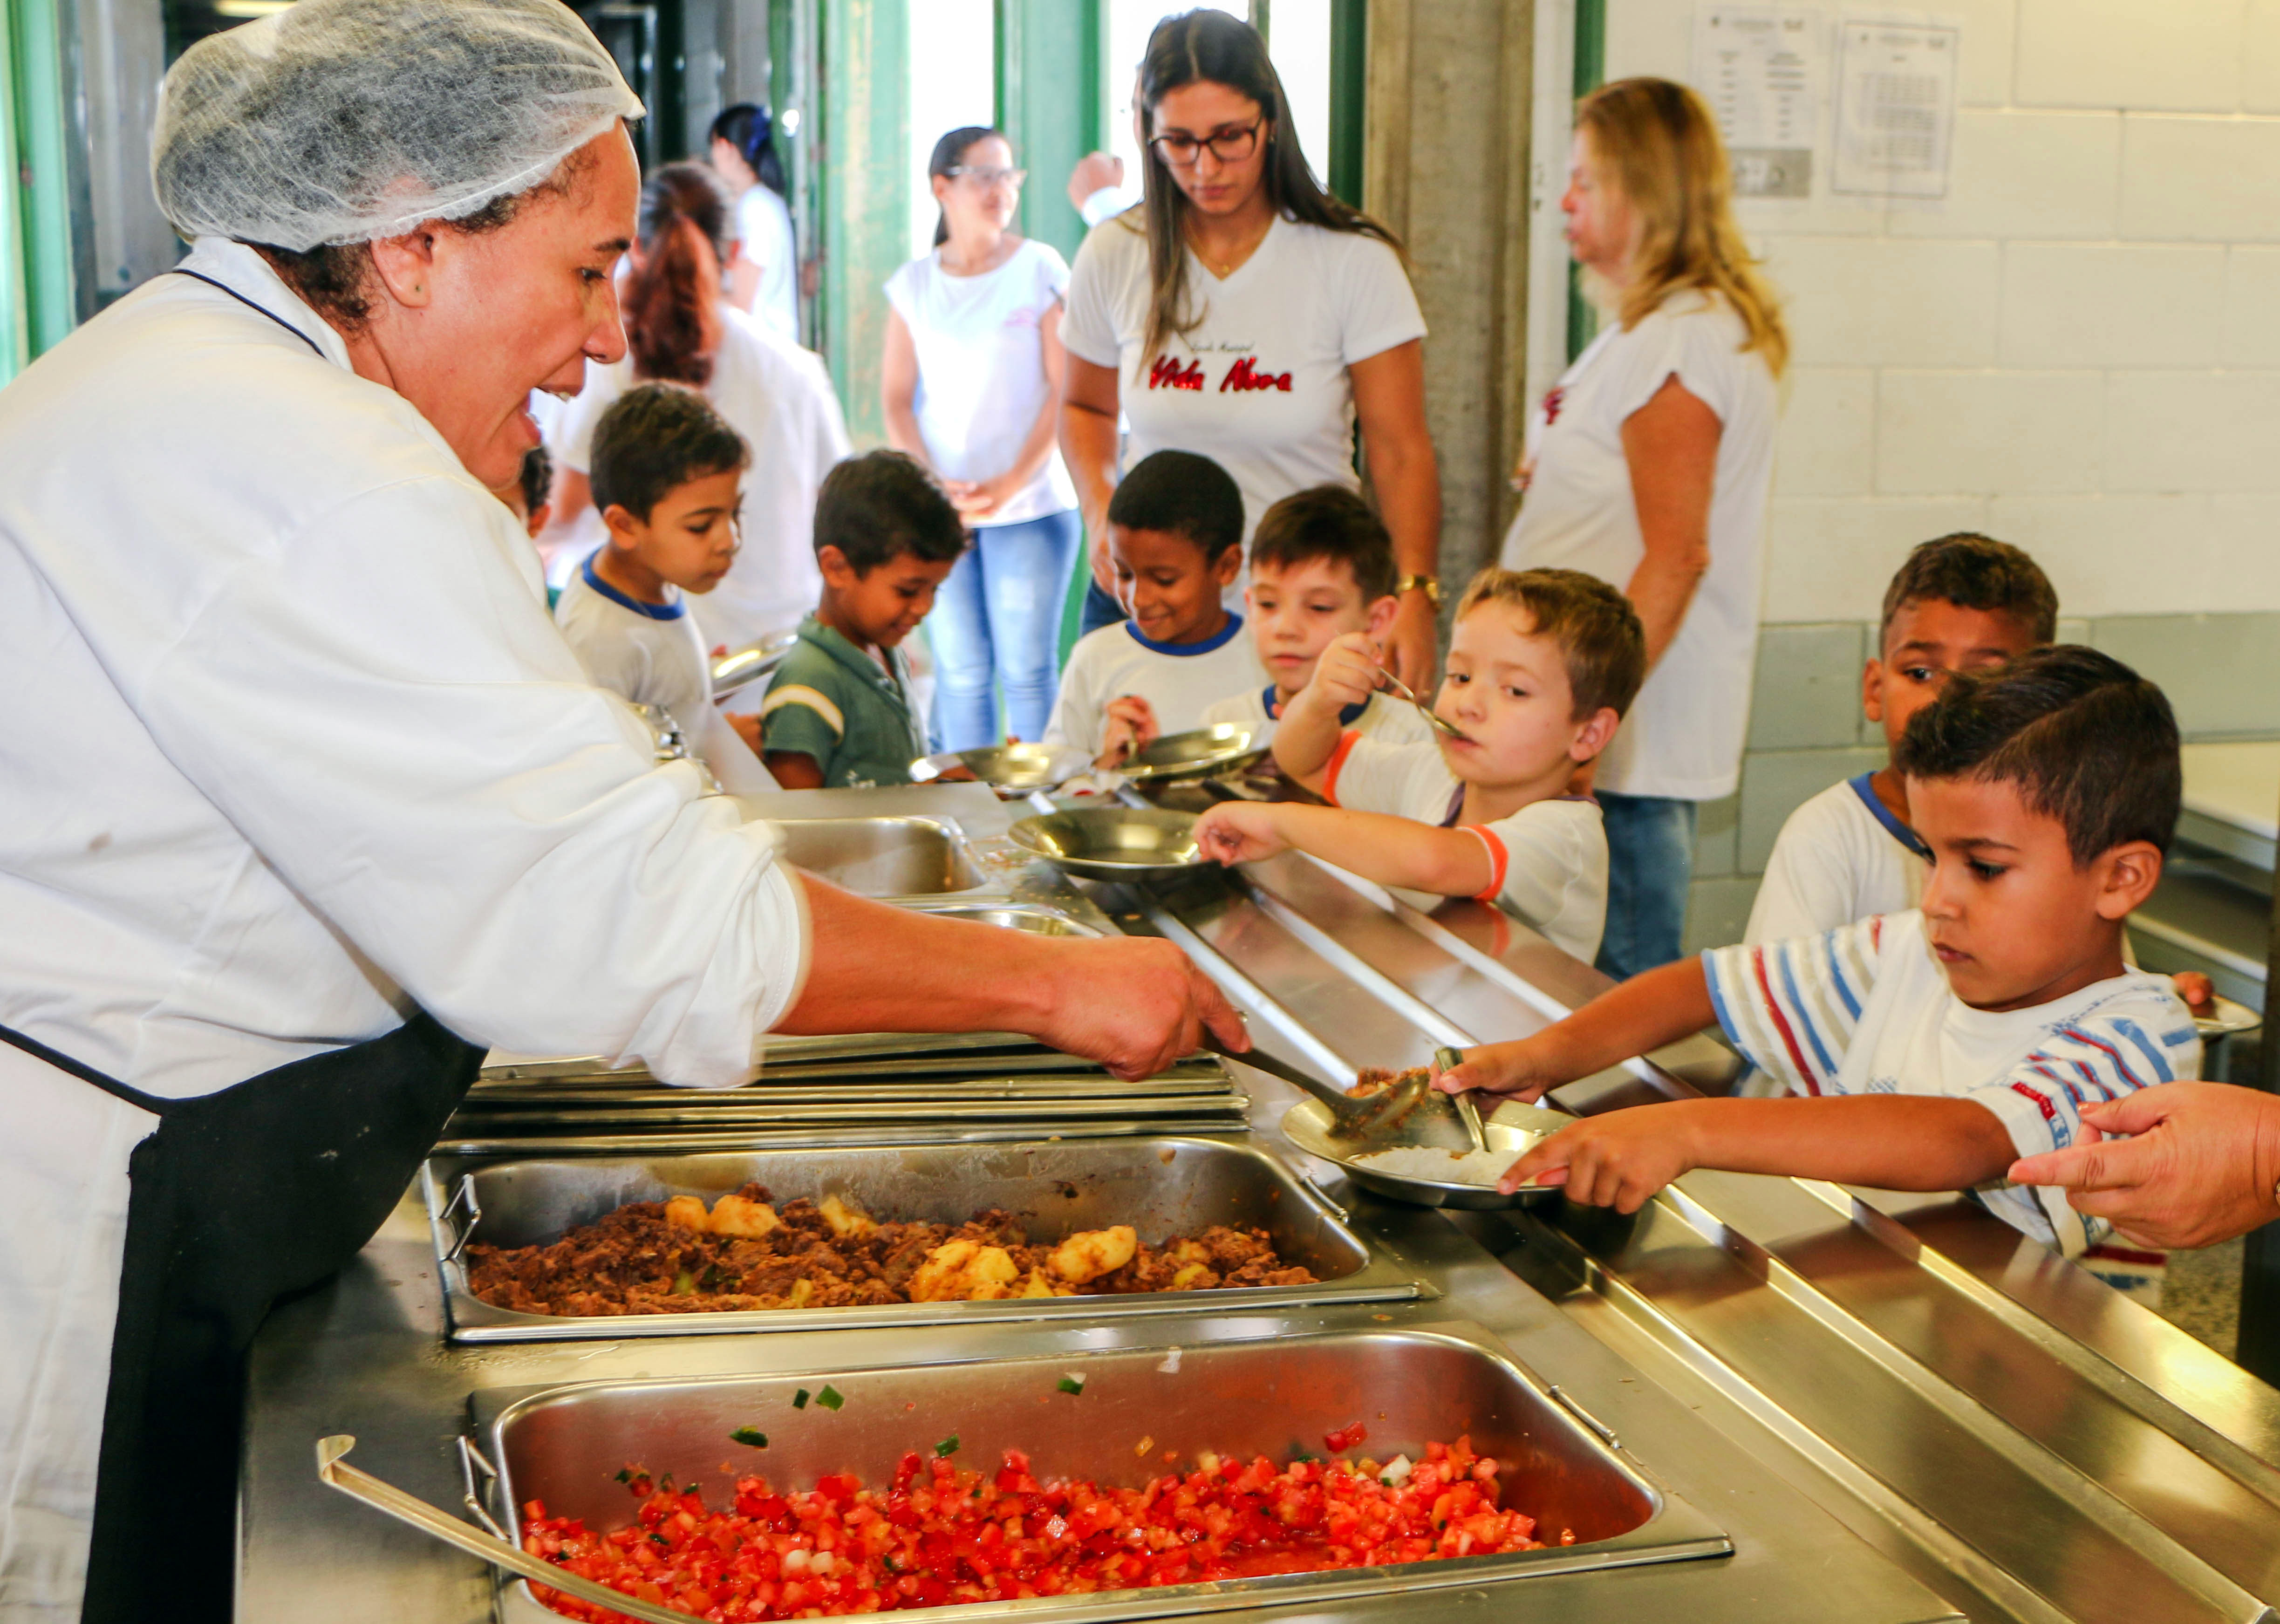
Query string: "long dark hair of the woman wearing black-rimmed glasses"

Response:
xmin=1117 ymin=11 xmax=1402 ymax=372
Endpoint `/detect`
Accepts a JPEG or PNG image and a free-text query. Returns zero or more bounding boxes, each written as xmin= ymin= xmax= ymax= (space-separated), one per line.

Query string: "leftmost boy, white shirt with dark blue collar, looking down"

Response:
xmin=554 ymin=383 xmax=775 ymax=794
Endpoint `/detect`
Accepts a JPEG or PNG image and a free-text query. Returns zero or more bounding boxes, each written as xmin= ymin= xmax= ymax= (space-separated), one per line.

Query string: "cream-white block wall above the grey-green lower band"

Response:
xmin=1607 ymin=0 xmax=2280 ymax=623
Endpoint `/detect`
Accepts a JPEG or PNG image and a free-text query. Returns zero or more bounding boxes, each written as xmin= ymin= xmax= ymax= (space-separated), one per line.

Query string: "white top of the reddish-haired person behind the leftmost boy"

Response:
xmin=556 ymin=301 xmax=850 ymax=650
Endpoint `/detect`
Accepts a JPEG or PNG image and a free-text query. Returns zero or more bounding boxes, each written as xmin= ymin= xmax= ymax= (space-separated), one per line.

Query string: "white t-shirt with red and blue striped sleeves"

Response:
xmin=1703 ymin=912 xmax=2200 ymax=1257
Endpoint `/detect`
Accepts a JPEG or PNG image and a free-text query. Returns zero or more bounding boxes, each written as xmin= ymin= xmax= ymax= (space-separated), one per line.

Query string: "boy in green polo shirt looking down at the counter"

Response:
xmin=759 ymin=451 xmax=967 ymax=789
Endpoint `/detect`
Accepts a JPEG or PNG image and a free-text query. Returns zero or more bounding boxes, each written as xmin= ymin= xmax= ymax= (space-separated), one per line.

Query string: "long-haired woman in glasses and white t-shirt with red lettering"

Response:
xmin=1060 ymin=11 xmax=1441 ymax=687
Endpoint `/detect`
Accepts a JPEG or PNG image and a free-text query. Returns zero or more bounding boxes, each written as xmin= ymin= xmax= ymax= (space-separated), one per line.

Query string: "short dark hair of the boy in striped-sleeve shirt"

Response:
xmin=1892 ymin=643 xmax=2182 ymax=867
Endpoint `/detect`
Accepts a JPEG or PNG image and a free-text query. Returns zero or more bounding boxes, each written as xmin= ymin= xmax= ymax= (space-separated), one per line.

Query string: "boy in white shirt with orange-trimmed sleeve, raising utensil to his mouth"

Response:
xmin=1195 ymin=568 xmax=1646 ymax=962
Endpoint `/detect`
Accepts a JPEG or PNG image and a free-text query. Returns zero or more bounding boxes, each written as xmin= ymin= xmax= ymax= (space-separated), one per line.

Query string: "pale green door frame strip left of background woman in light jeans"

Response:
xmin=809 ymin=0 xmax=898 ymax=447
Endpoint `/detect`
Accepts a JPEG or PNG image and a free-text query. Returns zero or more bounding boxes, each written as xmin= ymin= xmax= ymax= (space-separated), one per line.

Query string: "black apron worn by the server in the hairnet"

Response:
xmin=0 ymin=1010 xmax=484 ymax=1624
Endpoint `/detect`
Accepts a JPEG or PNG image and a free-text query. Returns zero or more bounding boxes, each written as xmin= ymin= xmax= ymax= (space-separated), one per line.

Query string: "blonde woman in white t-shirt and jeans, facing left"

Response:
xmin=1502 ymin=77 xmax=1790 ymax=976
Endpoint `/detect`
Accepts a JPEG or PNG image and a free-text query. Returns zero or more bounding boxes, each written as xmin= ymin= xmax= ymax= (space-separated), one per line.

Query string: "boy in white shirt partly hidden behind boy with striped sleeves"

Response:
xmin=1742 ymin=532 xmax=2059 ymax=944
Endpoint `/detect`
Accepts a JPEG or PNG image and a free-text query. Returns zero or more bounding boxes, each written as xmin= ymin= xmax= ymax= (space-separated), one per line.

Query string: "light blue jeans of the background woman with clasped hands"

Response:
xmin=926 ymin=511 xmax=1081 ymax=751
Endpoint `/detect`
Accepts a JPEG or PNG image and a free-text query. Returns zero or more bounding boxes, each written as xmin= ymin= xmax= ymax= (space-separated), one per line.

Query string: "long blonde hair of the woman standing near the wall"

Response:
xmin=1576 ymin=77 xmax=1790 ymax=379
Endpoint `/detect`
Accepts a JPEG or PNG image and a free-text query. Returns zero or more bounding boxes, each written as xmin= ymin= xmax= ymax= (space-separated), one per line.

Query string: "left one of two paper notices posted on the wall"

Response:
xmin=1694 ymin=7 xmax=1829 ymax=198
